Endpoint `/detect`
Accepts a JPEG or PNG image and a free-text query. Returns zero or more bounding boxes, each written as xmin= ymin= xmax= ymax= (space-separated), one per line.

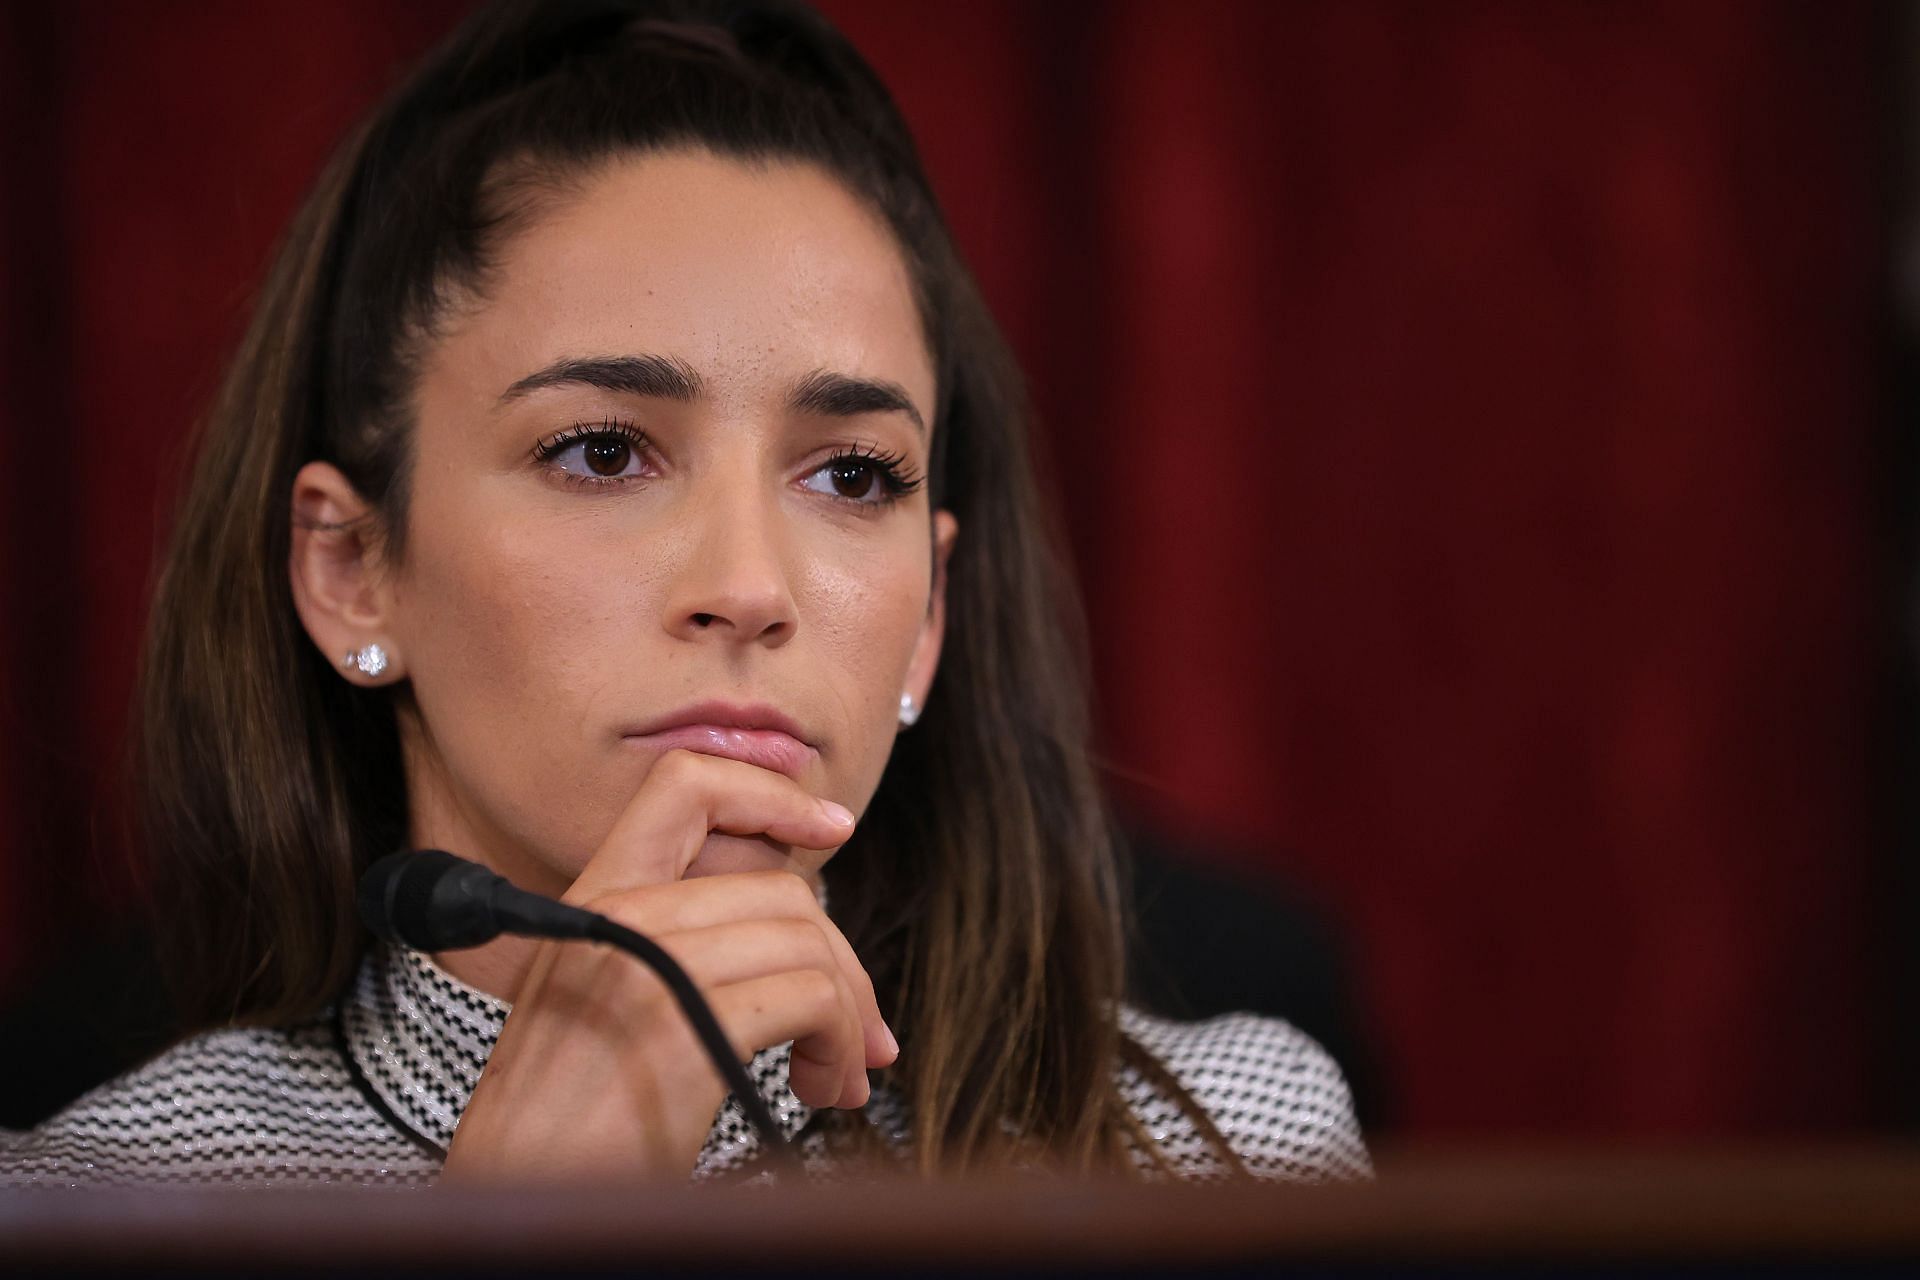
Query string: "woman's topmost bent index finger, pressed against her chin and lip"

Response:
xmin=566 ymin=750 xmax=852 ymax=902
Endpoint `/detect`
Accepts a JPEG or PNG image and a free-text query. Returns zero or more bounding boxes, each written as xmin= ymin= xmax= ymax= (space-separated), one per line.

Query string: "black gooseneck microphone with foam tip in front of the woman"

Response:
xmin=359 ymin=848 xmax=801 ymax=1173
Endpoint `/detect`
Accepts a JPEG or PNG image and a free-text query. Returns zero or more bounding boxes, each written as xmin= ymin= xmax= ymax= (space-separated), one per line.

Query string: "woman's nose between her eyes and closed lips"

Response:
xmin=666 ymin=477 xmax=799 ymax=649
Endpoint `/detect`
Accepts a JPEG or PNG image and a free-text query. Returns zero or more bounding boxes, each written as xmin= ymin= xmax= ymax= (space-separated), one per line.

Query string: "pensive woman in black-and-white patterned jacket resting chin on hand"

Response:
xmin=0 ymin=0 xmax=1365 ymax=1182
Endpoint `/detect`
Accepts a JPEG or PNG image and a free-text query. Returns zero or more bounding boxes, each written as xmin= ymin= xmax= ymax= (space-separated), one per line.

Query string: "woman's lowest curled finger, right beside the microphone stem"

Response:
xmin=708 ymin=969 xmax=868 ymax=1107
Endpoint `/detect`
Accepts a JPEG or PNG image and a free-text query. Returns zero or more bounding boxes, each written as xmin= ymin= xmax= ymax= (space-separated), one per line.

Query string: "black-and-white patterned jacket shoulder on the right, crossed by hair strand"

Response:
xmin=1119 ymin=1007 xmax=1373 ymax=1182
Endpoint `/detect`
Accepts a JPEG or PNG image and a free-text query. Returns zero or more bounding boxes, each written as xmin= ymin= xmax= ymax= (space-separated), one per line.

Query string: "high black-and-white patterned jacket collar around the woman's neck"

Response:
xmin=340 ymin=946 xmax=812 ymax=1178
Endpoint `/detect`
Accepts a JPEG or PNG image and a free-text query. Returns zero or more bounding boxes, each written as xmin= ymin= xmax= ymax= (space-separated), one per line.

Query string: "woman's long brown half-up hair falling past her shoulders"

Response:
xmin=142 ymin=0 xmax=1213 ymax=1171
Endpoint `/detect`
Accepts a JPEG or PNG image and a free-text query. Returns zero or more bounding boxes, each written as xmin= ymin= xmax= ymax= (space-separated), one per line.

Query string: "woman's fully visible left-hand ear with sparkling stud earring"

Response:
xmin=288 ymin=462 xmax=405 ymax=685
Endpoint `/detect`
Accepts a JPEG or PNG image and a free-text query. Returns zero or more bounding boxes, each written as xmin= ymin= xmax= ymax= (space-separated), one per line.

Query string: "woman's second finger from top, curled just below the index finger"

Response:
xmin=589 ymin=871 xmax=900 ymax=1067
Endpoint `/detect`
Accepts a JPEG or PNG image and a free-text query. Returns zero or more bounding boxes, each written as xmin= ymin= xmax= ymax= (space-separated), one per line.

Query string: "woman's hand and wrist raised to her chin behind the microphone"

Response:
xmin=445 ymin=750 xmax=899 ymax=1178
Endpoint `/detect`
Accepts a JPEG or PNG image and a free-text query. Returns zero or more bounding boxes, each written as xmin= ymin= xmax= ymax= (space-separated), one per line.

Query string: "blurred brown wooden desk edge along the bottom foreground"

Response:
xmin=0 ymin=1148 xmax=1920 ymax=1270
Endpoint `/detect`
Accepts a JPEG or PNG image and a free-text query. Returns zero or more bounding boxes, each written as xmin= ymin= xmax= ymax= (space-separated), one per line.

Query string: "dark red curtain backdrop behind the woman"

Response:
xmin=0 ymin=0 xmax=1895 ymax=1136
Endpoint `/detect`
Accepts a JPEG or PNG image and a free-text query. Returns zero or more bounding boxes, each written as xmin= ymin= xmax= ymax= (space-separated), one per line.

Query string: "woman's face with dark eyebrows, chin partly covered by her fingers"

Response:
xmin=330 ymin=152 xmax=954 ymax=890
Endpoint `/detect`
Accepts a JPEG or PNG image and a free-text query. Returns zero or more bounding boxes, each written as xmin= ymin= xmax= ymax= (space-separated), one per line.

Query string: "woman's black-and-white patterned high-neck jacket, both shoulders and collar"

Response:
xmin=0 ymin=950 xmax=1369 ymax=1186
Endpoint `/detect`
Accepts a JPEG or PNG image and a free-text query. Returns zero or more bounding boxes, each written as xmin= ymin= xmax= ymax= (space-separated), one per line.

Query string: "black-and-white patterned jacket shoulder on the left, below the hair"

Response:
xmin=0 ymin=1021 xmax=434 ymax=1186
